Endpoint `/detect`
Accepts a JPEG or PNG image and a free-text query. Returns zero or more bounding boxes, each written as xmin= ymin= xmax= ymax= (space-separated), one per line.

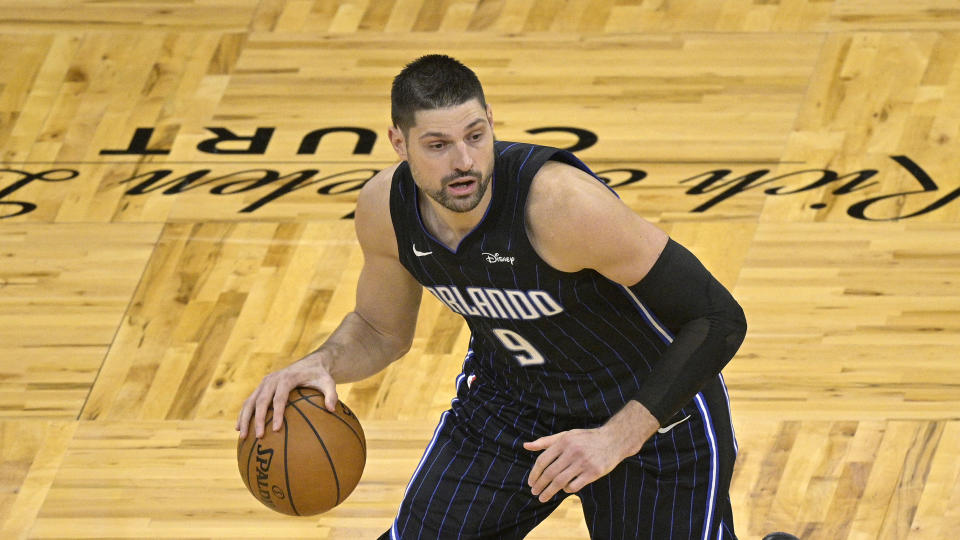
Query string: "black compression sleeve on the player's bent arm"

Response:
xmin=630 ymin=239 xmax=747 ymax=426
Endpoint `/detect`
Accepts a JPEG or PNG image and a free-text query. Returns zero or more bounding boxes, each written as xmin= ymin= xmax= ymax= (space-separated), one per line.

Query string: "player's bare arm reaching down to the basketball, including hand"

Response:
xmin=236 ymin=166 xmax=423 ymax=438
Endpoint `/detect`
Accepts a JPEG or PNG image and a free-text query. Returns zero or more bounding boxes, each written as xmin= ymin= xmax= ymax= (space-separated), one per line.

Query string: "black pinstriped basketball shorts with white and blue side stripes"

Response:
xmin=381 ymin=377 xmax=736 ymax=540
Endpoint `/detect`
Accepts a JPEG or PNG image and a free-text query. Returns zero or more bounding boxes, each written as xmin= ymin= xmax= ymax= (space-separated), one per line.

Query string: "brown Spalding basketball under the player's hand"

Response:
xmin=237 ymin=388 xmax=367 ymax=516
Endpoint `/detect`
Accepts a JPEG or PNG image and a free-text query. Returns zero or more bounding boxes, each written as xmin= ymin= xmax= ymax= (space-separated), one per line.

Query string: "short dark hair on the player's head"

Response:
xmin=390 ymin=54 xmax=487 ymax=134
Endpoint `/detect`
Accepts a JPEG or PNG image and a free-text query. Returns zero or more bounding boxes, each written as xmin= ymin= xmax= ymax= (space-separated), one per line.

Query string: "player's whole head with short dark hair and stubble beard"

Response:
xmin=390 ymin=55 xmax=494 ymax=212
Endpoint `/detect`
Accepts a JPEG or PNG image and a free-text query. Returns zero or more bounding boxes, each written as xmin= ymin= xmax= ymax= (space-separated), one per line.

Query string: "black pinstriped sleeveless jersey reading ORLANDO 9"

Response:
xmin=390 ymin=141 xmax=669 ymax=446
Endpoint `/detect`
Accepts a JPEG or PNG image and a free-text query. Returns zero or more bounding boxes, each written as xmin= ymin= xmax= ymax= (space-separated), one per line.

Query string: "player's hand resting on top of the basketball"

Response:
xmin=236 ymin=353 xmax=338 ymax=439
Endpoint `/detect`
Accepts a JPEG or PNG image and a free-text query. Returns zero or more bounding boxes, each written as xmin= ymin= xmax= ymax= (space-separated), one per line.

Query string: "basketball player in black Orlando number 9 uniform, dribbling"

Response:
xmin=237 ymin=55 xmax=746 ymax=540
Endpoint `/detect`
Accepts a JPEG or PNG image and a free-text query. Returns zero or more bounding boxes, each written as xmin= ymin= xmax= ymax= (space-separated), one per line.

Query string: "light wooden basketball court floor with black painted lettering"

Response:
xmin=0 ymin=0 xmax=960 ymax=540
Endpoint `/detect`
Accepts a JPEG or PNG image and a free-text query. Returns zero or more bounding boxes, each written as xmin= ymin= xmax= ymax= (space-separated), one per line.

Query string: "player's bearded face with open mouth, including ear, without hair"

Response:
xmin=390 ymin=99 xmax=494 ymax=212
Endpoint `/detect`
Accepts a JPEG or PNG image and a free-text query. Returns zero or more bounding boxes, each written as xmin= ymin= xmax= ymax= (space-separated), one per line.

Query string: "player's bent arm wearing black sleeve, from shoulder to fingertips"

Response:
xmin=525 ymin=162 xmax=746 ymax=501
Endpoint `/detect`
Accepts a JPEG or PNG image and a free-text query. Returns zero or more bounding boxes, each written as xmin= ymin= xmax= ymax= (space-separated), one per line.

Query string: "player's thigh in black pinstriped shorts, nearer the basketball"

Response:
xmin=391 ymin=412 xmax=559 ymax=540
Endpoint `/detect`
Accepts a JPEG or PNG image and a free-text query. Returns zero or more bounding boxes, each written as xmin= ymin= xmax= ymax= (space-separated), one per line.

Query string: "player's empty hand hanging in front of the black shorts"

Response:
xmin=523 ymin=428 xmax=630 ymax=503
